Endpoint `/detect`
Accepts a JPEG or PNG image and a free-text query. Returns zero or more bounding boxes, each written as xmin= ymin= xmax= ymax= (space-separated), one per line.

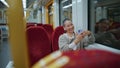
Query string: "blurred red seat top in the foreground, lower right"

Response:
xmin=63 ymin=50 xmax=120 ymax=68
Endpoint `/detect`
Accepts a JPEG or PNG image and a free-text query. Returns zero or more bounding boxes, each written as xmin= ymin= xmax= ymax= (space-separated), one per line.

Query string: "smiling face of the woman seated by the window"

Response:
xmin=64 ymin=20 xmax=74 ymax=33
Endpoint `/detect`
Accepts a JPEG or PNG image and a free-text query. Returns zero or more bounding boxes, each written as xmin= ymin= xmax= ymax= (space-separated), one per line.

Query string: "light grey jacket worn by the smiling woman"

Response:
xmin=59 ymin=33 xmax=95 ymax=51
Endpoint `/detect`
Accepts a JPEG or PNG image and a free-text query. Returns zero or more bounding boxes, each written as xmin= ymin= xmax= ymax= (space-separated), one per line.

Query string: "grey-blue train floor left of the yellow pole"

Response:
xmin=0 ymin=39 xmax=12 ymax=68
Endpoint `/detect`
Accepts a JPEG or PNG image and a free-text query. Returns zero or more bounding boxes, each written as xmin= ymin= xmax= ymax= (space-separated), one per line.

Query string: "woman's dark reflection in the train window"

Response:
xmin=95 ymin=19 xmax=120 ymax=49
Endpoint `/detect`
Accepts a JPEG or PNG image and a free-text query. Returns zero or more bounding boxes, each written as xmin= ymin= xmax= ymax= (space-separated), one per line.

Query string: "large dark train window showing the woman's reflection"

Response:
xmin=89 ymin=0 xmax=120 ymax=49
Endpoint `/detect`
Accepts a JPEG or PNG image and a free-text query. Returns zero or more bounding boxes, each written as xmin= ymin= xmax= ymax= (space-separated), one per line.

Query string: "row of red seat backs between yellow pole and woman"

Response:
xmin=26 ymin=24 xmax=64 ymax=66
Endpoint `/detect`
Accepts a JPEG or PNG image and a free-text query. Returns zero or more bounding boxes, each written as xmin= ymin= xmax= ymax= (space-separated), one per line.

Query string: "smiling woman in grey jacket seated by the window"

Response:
xmin=59 ymin=19 xmax=95 ymax=51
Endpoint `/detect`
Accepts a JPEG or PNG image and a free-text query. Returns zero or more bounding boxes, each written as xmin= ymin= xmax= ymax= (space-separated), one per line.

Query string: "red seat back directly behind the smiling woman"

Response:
xmin=52 ymin=26 xmax=64 ymax=51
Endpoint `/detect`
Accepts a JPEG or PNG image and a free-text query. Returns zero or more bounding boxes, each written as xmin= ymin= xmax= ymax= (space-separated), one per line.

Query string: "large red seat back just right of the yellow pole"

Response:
xmin=26 ymin=26 xmax=52 ymax=66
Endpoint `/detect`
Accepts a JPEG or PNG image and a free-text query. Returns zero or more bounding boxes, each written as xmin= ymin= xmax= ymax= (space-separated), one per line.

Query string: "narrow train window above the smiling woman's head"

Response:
xmin=60 ymin=0 xmax=72 ymax=25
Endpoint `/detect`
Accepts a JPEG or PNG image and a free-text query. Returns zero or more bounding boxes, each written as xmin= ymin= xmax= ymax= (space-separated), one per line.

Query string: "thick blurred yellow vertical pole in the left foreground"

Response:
xmin=7 ymin=0 xmax=29 ymax=68
